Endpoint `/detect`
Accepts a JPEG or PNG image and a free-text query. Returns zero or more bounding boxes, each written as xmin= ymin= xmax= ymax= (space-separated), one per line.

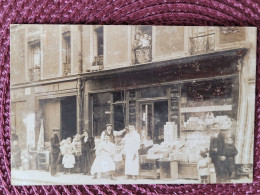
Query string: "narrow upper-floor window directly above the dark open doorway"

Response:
xmin=62 ymin=31 xmax=71 ymax=76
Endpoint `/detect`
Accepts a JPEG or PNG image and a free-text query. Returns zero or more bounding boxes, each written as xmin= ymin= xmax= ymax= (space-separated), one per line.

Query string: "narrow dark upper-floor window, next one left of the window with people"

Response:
xmin=94 ymin=26 xmax=104 ymax=66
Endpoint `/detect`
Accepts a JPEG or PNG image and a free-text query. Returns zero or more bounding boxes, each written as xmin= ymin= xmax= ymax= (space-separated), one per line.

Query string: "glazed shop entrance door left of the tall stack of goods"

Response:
xmin=140 ymin=100 xmax=168 ymax=143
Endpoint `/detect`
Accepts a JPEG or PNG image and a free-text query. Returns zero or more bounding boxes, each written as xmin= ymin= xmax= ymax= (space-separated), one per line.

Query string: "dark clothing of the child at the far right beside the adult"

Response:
xmin=224 ymin=144 xmax=238 ymax=177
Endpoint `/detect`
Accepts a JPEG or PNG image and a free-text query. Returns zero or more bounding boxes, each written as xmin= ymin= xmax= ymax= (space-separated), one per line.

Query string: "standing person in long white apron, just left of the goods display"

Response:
xmin=123 ymin=126 xmax=140 ymax=179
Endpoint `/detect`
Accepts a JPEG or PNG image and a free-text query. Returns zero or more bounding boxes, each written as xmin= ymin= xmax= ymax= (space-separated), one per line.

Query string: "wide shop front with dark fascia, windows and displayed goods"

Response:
xmin=82 ymin=50 xmax=245 ymax=179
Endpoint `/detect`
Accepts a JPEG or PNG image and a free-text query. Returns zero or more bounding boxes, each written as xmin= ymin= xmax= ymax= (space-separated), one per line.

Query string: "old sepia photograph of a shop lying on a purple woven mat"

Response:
xmin=10 ymin=24 xmax=256 ymax=185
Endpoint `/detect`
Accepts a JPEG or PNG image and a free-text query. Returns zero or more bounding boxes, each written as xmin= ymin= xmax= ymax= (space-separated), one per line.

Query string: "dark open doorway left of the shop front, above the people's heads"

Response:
xmin=60 ymin=96 xmax=77 ymax=139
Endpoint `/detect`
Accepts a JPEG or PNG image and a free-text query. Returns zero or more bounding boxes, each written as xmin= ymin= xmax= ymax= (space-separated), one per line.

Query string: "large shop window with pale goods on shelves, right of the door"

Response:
xmin=180 ymin=78 xmax=238 ymax=131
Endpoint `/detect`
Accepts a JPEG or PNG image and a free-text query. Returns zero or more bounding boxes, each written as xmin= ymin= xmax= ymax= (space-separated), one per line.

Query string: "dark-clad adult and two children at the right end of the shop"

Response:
xmin=197 ymin=129 xmax=238 ymax=183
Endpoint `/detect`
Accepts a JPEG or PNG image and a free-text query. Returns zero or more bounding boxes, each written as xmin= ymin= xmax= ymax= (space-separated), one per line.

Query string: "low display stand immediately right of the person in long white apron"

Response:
xmin=139 ymin=155 xmax=159 ymax=179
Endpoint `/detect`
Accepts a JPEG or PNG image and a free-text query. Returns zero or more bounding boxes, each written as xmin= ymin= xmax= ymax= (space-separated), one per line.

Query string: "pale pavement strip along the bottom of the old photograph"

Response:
xmin=11 ymin=170 xmax=252 ymax=186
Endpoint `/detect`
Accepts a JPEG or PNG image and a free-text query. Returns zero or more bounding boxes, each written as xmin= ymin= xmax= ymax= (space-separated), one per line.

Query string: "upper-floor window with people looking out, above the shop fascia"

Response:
xmin=133 ymin=26 xmax=152 ymax=64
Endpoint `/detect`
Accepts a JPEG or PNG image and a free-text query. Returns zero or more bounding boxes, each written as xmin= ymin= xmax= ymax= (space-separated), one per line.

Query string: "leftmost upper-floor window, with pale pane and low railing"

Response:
xmin=29 ymin=41 xmax=41 ymax=81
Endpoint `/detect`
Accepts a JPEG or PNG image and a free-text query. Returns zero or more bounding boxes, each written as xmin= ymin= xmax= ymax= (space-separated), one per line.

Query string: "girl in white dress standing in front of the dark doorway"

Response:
xmin=62 ymin=137 xmax=75 ymax=174
